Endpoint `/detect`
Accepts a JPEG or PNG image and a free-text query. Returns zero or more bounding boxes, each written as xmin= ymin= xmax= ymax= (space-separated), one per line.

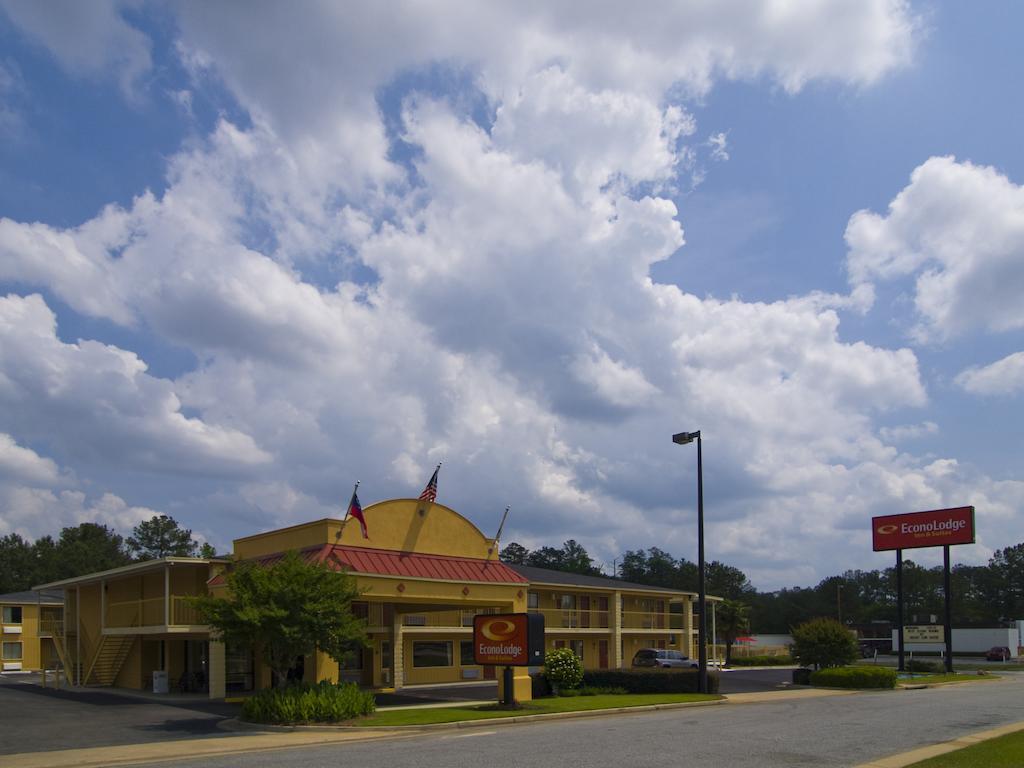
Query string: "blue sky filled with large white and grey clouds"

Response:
xmin=0 ymin=0 xmax=1024 ymax=590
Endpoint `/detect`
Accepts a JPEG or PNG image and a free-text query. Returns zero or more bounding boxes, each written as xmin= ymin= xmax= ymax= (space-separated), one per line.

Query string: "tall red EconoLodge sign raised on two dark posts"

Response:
xmin=871 ymin=507 xmax=974 ymax=672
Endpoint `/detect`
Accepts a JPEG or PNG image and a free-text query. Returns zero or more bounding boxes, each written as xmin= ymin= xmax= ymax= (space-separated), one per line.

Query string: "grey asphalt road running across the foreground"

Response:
xmin=142 ymin=676 xmax=1024 ymax=768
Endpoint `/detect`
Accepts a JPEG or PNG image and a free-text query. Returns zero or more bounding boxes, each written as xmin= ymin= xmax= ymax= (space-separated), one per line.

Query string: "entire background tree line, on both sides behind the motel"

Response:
xmin=0 ymin=515 xmax=1024 ymax=633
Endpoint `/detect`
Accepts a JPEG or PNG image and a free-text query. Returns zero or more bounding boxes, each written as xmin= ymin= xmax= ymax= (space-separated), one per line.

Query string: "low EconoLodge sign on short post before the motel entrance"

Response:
xmin=473 ymin=613 xmax=544 ymax=707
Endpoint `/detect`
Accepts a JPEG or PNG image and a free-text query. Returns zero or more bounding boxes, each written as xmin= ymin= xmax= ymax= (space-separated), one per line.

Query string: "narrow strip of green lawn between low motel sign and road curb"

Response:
xmin=351 ymin=693 xmax=722 ymax=727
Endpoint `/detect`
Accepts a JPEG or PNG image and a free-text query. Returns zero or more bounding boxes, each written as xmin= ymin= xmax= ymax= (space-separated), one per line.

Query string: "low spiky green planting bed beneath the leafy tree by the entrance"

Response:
xmin=242 ymin=680 xmax=375 ymax=723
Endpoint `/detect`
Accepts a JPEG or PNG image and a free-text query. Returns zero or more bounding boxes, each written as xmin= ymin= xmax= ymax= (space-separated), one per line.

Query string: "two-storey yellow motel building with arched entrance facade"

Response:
xmin=34 ymin=499 xmax=714 ymax=700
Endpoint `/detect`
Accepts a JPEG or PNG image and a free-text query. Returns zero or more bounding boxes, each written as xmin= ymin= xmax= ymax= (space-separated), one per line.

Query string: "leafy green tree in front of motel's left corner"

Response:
xmin=193 ymin=552 xmax=366 ymax=686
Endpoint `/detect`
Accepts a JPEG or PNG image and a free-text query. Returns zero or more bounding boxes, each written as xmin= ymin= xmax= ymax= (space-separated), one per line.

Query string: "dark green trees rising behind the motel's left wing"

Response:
xmin=0 ymin=515 xmax=214 ymax=594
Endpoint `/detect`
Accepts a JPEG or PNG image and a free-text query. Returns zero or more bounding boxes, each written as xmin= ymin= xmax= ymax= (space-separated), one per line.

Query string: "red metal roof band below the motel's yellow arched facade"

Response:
xmin=210 ymin=544 xmax=529 ymax=586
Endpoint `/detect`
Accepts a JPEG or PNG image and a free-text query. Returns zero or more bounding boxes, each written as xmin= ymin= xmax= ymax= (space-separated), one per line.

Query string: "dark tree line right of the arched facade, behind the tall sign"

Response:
xmin=501 ymin=540 xmax=1024 ymax=634
